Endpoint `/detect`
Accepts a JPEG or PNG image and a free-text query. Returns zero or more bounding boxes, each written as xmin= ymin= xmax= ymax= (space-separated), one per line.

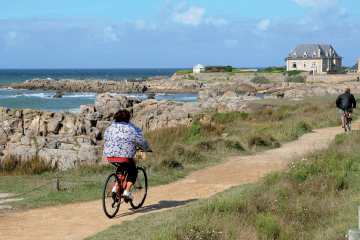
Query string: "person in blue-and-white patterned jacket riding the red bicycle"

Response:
xmin=104 ymin=110 xmax=151 ymax=200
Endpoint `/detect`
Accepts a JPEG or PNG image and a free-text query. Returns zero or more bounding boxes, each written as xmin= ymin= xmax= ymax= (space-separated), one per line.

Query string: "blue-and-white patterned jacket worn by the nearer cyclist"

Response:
xmin=104 ymin=122 xmax=150 ymax=158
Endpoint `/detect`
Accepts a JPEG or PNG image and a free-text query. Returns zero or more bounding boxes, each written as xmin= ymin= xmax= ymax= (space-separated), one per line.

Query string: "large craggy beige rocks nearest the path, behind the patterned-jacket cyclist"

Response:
xmin=0 ymin=91 xmax=260 ymax=170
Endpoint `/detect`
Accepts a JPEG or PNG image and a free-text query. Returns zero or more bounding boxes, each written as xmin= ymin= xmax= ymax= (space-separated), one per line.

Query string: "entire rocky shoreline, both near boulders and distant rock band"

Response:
xmin=0 ymin=77 xmax=360 ymax=170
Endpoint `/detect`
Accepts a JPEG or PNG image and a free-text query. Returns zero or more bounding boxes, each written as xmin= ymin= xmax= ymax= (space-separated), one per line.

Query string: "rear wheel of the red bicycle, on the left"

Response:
xmin=102 ymin=173 xmax=120 ymax=218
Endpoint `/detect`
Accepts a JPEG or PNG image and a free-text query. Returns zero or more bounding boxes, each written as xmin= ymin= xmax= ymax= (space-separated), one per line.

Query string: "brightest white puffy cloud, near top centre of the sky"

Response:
xmin=172 ymin=4 xmax=206 ymax=26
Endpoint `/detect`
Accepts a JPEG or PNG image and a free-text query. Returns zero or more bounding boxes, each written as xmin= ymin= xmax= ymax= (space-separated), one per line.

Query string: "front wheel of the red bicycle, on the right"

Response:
xmin=130 ymin=167 xmax=147 ymax=209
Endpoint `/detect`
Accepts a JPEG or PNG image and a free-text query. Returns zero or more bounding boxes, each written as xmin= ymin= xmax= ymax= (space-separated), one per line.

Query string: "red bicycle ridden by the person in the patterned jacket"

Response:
xmin=102 ymin=162 xmax=148 ymax=218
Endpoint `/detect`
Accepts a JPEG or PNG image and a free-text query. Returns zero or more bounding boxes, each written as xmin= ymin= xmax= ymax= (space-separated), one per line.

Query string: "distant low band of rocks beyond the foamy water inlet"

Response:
xmin=4 ymin=75 xmax=360 ymax=98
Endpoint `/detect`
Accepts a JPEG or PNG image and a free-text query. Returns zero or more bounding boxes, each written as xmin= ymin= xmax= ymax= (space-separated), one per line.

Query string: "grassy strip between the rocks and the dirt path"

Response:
xmin=0 ymin=97 xmax=348 ymax=212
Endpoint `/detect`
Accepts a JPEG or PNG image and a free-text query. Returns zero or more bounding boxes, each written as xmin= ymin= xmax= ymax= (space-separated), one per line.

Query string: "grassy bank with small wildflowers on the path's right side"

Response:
xmin=90 ymin=118 xmax=360 ymax=240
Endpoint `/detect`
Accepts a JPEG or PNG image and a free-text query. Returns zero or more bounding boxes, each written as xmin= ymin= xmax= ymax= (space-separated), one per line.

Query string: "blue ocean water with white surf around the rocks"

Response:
xmin=0 ymin=68 xmax=263 ymax=113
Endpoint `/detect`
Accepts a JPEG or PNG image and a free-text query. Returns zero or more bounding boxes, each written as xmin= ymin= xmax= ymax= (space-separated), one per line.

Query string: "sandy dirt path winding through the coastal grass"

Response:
xmin=0 ymin=120 xmax=360 ymax=239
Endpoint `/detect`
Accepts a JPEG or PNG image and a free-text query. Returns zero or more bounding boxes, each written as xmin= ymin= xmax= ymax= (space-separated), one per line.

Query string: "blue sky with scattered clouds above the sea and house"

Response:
xmin=0 ymin=0 xmax=360 ymax=69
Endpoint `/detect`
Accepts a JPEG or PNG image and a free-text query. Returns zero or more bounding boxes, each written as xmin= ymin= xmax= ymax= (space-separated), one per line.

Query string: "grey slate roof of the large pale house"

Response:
xmin=287 ymin=44 xmax=341 ymax=59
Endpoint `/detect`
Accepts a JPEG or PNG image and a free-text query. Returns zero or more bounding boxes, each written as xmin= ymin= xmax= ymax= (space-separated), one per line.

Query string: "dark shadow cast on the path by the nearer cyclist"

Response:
xmin=115 ymin=199 xmax=199 ymax=218
